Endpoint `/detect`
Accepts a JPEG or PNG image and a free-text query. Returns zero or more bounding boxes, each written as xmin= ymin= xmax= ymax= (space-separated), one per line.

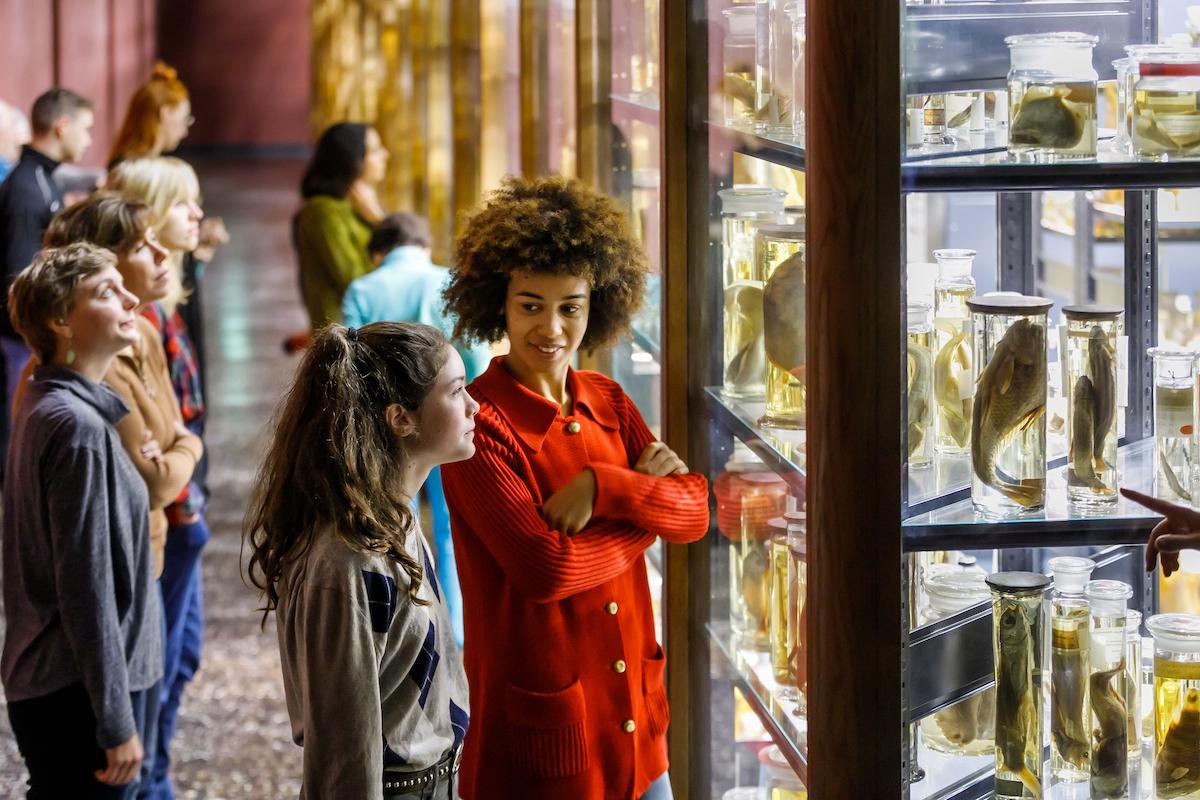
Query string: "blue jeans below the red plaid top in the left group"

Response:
xmin=138 ymin=516 xmax=209 ymax=800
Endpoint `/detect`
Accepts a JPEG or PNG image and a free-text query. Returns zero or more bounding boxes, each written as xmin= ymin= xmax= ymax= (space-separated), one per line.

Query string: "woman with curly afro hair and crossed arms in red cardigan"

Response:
xmin=444 ymin=178 xmax=708 ymax=800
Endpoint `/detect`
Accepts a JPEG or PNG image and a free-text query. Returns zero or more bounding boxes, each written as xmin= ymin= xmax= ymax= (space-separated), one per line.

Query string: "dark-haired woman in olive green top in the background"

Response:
xmin=293 ymin=122 xmax=388 ymax=331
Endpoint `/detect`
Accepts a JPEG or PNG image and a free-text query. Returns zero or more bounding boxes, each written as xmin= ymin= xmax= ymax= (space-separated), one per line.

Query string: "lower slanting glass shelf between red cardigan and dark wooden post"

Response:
xmin=706 ymin=621 xmax=809 ymax=783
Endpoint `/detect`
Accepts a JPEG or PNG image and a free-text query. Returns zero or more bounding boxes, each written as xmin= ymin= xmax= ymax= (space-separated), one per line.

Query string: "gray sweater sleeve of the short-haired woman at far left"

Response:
xmin=47 ymin=446 xmax=137 ymax=748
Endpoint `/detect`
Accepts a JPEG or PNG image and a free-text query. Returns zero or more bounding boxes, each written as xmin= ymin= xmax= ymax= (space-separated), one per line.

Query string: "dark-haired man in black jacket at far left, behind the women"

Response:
xmin=0 ymin=88 xmax=94 ymax=476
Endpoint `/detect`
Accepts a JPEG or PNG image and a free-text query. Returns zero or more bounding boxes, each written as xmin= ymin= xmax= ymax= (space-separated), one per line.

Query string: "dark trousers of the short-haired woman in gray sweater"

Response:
xmin=8 ymin=684 xmax=158 ymax=800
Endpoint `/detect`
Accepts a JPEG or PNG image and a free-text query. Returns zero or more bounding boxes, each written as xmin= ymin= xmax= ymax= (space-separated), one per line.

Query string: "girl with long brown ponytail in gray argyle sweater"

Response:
xmin=245 ymin=323 xmax=479 ymax=800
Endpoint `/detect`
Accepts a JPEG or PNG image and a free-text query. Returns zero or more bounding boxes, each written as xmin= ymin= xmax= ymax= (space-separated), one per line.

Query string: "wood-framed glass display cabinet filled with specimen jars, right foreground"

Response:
xmin=662 ymin=0 xmax=1200 ymax=800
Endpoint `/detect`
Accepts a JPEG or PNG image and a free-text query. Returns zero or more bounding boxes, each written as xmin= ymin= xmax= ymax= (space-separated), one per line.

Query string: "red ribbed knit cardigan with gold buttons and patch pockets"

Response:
xmin=443 ymin=359 xmax=708 ymax=800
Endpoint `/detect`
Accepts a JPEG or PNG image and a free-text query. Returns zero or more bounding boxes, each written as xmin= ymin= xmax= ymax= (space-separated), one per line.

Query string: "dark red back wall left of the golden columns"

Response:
xmin=158 ymin=0 xmax=311 ymax=146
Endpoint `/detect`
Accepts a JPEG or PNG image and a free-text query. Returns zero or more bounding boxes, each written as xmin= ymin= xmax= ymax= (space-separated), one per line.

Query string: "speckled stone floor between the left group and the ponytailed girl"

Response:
xmin=0 ymin=161 xmax=306 ymax=800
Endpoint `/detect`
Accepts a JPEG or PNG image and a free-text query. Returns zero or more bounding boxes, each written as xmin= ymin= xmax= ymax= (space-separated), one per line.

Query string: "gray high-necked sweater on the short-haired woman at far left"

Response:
xmin=0 ymin=366 xmax=162 ymax=748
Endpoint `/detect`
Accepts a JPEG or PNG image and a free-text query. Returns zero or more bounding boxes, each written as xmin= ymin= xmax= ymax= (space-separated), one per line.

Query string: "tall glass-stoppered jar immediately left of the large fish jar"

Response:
xmin=934 ymin=249 xmax=976 ymax=456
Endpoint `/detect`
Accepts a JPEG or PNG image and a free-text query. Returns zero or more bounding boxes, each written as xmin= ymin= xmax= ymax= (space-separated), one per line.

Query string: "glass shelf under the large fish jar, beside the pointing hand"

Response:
xmin=902 ymin=439 xmax=1160 ymax=553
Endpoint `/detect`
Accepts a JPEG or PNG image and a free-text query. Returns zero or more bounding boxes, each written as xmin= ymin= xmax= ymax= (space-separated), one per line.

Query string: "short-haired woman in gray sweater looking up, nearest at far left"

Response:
xmin=0 ymin=245 xmax=162 ymax=800
